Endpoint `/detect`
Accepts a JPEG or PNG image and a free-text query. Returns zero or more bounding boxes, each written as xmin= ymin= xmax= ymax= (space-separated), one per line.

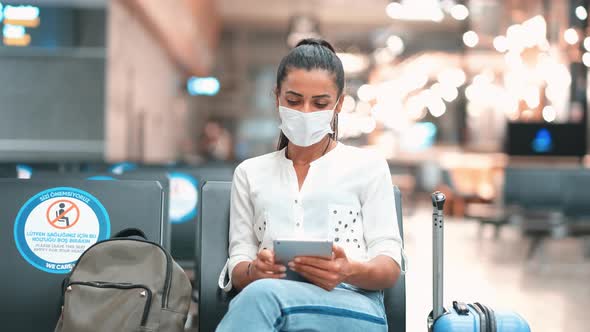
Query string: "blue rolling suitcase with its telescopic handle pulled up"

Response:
xmin=428 ymin=192 xmax=530 ymax=332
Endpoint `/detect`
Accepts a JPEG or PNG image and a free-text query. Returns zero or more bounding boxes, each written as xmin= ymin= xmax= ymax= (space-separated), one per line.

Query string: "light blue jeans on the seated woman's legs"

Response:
xmin=216 ymin=279 xmax=387 ymax=332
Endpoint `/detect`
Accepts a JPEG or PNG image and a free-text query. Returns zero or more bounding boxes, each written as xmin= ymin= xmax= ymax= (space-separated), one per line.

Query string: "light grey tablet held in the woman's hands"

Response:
xmin=273 ymin=239 xmax=332 ymax=281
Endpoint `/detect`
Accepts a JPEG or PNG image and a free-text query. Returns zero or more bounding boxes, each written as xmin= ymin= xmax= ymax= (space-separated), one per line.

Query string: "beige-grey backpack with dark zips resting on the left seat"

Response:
xmin=55 ymin=229 xmax=192 ymax=332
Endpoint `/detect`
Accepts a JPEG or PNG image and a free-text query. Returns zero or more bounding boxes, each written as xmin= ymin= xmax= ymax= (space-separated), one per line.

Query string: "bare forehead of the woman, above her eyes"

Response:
xmin=281 ymin=69 xmax=337 ymax=96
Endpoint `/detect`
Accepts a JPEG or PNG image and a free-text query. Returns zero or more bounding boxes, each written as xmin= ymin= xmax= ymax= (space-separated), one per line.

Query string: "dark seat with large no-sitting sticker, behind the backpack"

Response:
xmin=0 ymin=179 xmax=164 ymax=331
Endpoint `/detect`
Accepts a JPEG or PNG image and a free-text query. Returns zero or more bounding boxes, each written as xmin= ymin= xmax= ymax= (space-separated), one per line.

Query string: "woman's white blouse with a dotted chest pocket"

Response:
xmin=219 ymin=143 xmax=403 ymax=291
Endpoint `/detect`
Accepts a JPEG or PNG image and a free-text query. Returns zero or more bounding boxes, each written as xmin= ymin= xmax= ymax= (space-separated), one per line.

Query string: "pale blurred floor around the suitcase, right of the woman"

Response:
xmin=404 ymin=207 xmax=590 ymax=332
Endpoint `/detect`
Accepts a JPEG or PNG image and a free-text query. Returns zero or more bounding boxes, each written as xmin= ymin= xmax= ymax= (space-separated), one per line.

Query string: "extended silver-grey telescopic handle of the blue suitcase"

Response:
xmin=431 ymin=191 xmax=446 ymax=320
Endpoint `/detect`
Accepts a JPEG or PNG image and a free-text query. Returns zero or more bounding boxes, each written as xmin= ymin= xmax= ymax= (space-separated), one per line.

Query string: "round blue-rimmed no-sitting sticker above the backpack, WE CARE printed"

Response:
xmin=14 ymin=187 xmax=111 ymax=274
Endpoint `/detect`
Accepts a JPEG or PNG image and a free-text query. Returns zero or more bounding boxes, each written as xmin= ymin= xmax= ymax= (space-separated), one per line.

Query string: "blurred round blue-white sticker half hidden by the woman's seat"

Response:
xmin=168 ymin=172 xmax=199 ymax=224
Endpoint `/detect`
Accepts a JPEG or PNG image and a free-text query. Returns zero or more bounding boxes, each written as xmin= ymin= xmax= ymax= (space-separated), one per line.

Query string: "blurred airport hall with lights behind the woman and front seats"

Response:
xmin=0 ymin=0 xmax=590 ymax=332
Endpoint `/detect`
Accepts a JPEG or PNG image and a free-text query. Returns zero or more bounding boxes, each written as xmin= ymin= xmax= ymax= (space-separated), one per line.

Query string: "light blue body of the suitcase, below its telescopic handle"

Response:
xmin=432 ymin=306 xmax=531 ymax=332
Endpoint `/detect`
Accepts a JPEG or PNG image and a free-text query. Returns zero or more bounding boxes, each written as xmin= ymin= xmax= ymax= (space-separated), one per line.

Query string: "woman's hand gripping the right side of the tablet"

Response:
xmin=289 ymin=245 xmax=352 ymax=291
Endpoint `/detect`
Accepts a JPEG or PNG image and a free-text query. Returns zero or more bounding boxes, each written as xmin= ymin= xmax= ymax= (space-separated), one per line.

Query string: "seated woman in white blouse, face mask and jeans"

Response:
xmin=217 ymin=39 xmax=402 ymax=331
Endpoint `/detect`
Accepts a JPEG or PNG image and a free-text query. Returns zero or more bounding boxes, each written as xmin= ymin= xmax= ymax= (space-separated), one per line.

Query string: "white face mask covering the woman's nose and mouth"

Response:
xmin=279 ymin=98 xmax=340 ymax=146
